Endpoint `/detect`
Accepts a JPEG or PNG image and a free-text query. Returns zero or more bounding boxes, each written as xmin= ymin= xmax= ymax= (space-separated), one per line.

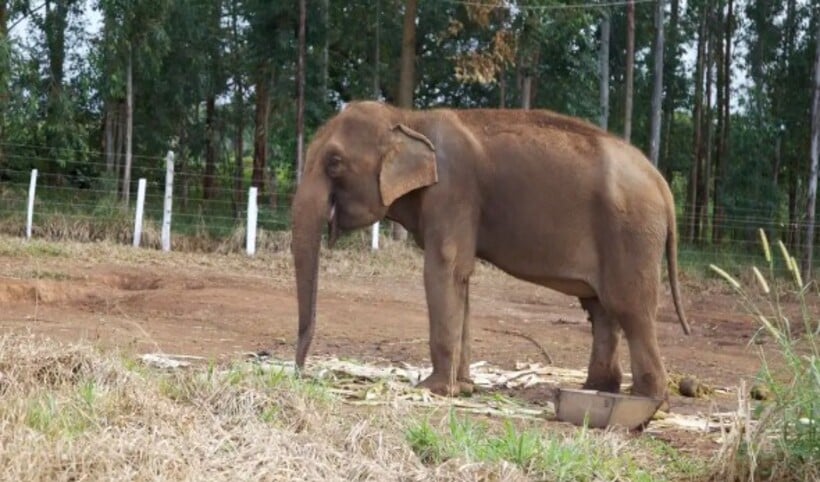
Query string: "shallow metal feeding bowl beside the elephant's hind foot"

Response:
xmin=555 ymin=388 xmax=663 ymax=430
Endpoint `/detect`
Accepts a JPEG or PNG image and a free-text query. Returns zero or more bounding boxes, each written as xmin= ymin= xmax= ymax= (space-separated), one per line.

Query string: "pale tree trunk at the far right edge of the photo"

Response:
xmin=803 ymin=18 xmax=820 ymax=283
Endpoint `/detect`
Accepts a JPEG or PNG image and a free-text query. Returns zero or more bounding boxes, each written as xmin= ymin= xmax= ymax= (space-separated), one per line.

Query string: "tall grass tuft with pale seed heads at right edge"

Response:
xmin=713 ymin=230 xmax=820 ymax=480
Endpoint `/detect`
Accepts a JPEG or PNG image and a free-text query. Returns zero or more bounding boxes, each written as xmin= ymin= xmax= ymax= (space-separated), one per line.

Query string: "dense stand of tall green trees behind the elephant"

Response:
xmin=0 ymin=0 xmax=820 ymax=272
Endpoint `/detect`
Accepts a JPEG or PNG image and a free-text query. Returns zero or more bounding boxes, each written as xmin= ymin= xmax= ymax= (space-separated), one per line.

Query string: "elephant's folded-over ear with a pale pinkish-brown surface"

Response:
xmin=379 ymin=124 xmax=438 ymax=206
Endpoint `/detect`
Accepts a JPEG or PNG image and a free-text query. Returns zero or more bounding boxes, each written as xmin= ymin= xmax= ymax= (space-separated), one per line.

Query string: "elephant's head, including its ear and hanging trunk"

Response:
xmin=291 ymin=102 xmax=438 ymax=367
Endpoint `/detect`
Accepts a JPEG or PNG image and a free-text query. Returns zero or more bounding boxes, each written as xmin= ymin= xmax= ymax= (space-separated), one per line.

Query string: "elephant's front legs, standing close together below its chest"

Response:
xmin=419 ymin=241 xmax=472 ymax=396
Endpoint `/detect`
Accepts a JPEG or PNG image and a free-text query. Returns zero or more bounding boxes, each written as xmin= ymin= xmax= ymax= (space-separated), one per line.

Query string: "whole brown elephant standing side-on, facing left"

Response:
xmin=291 ymin=101 xmax=690 ymax=399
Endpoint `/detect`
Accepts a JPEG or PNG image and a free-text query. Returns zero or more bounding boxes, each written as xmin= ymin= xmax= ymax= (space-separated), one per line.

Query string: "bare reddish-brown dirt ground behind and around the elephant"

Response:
xmin=0 ymin=240 xmax=808 ymax=452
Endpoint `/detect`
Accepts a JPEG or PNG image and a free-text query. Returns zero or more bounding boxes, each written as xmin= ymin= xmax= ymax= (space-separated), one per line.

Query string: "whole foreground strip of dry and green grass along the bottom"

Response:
xmin=0 ymin=335 xmax=712 ymax=481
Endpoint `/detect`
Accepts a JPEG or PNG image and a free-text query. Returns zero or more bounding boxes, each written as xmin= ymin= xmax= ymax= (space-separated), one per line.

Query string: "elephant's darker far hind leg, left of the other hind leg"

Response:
xmin=580 ymin=298 xmax=622 ymax=393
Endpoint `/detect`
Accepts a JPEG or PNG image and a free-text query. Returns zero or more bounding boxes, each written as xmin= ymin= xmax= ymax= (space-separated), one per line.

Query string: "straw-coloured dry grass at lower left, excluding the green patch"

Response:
xmin=0 ymin=336 xmax=540 ymax=481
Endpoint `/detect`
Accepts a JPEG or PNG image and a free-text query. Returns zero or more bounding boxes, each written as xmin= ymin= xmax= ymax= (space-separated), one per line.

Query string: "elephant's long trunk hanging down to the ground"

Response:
xmin=291 ymin=179 xmax=335 ymax=368
